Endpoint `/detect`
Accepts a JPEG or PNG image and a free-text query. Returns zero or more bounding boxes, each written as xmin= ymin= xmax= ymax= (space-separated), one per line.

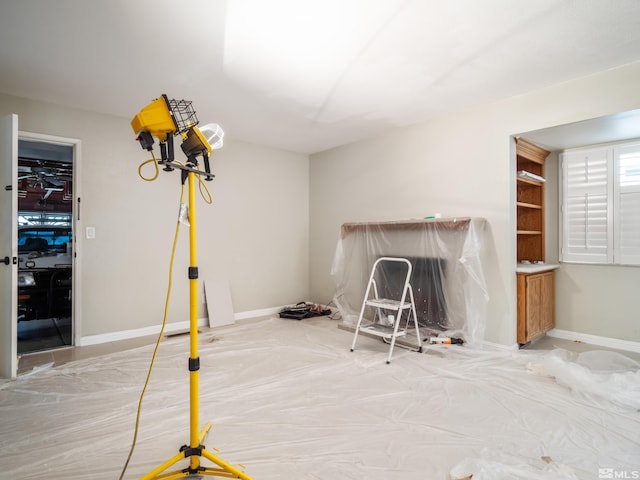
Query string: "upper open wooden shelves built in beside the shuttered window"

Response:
xmin=516 ymin=138 xmax=549 ymax=262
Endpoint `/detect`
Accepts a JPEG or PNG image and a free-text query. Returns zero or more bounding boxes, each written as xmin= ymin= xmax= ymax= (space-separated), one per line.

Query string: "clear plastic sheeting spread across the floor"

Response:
xmin=0 ymin=317 xmax=640 ymax=480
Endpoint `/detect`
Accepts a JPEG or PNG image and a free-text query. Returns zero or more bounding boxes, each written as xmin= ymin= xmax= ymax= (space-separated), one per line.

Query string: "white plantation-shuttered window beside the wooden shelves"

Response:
xmin=560 ymin=142 xmax=640 ymax=265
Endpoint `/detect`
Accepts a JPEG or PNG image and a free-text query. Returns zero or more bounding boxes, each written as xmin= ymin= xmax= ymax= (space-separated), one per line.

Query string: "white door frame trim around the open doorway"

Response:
xmin=15 ymin=130 xmax=82 ymax=345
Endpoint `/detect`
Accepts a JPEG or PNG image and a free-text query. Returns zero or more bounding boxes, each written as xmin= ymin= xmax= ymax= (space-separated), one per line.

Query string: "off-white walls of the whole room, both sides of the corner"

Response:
xmin=5 ymin=63 xmax=640 ymax=345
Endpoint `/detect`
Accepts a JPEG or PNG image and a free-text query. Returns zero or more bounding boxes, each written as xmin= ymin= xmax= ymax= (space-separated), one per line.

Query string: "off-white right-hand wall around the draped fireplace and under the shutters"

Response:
xmin=310 ymin=63 xmax=640 ymax=345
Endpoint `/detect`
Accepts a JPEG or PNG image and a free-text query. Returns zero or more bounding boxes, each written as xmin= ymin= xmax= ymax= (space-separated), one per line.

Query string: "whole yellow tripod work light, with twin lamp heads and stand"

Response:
xmin=131 ymin=95 xmax=252 ymax=480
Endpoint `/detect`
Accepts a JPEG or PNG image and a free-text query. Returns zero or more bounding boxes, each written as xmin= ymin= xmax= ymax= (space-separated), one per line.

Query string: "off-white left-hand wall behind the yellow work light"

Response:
xmin=0 ymin=94 xmax=309 ymax=337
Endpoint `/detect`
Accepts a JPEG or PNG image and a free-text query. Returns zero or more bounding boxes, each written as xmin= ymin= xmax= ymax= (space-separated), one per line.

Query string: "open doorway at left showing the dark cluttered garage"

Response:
xmin=16 ymin=137 xmax=75 ymax=354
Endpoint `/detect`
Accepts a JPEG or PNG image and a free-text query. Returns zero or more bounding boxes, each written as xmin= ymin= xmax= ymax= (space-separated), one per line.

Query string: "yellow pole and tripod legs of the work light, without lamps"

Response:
xmin=140 ymin=171 xmax=253 ymax=480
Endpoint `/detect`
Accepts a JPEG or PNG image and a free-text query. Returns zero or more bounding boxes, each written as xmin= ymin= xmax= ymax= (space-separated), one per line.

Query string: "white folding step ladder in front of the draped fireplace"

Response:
xmin=351 ymin=257 xmax=422 ymax=363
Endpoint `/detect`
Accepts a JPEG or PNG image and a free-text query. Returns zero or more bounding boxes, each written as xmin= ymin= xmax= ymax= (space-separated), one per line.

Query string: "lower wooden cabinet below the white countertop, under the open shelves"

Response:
xmin=517 ymin=270 xmax=555 ymax=345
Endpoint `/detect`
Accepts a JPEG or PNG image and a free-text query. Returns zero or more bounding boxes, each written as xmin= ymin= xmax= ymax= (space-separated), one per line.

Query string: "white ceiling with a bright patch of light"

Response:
xmin=0 ymin=0 xmax=640 ymax=153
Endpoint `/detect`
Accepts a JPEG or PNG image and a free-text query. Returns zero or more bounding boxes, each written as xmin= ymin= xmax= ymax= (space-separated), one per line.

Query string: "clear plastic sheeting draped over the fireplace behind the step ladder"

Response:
xmin=331 ymin=217 xmax=489 ymax=344
